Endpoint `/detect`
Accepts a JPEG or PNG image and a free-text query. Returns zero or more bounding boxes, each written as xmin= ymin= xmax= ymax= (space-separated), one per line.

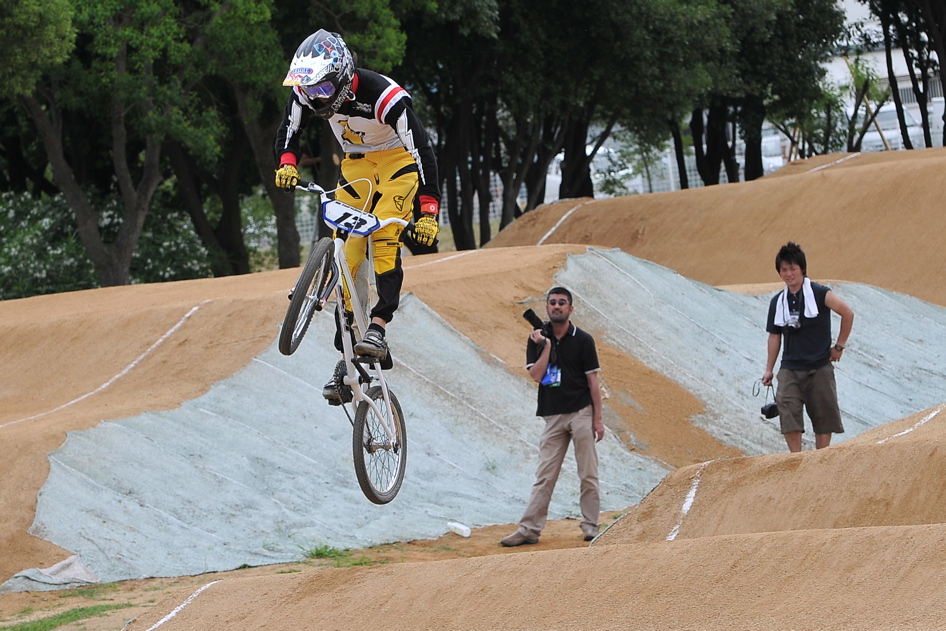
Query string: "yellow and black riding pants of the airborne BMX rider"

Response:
xmin=335 ymin=148 xmax=419 ymax=322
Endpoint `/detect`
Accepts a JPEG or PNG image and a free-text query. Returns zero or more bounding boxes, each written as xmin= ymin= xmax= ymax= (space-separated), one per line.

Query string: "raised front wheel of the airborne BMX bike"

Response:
xmin=279 ymin=237 xmax=335 ymax=355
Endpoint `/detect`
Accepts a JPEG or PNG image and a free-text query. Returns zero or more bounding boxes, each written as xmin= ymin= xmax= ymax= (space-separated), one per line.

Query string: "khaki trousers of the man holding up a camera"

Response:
xmin=519 ymin=405 xmax=601 ymax=537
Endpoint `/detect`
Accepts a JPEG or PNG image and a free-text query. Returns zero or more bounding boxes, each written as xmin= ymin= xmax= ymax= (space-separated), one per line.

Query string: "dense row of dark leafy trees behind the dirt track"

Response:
xmin=0 ymin=0 xmax=856 ymax=292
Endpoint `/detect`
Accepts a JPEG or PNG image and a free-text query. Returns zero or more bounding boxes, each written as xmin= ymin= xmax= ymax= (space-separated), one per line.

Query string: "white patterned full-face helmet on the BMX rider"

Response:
xmin=282 ymin=29 xmax=355 ymax=118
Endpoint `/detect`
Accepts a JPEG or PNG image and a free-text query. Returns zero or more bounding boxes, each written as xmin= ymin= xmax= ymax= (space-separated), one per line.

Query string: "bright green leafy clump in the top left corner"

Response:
xmin=0 ymin=0 xmax=75 ymax=97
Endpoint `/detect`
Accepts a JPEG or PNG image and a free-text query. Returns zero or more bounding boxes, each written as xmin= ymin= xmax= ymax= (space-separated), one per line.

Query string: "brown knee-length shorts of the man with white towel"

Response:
xmin=775 ymin=363 xmax=844 ymax=434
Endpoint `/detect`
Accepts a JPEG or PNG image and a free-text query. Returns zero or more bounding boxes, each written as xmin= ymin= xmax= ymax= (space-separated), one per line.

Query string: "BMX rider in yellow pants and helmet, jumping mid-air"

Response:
xmin=275 ymin=29 xmax=440 ymax=404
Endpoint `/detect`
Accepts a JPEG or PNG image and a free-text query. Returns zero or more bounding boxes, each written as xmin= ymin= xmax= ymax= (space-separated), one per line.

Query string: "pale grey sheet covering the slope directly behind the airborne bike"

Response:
xmin=5 ymin=295 xmax=667 ymax=589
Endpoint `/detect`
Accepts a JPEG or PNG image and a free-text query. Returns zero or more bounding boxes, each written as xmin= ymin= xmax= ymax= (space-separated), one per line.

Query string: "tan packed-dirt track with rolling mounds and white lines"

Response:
xmin=0 ymin=149 xmax=946 ymax=630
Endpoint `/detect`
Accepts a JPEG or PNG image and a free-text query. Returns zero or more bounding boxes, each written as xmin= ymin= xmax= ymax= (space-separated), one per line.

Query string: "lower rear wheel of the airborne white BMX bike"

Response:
xmin=352 ymin=386 xmax=407 ymax=504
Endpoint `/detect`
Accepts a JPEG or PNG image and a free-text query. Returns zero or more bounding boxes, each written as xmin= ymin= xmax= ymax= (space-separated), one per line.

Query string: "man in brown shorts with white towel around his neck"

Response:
xmin=762 ymin=241 xmax=854 ymax=452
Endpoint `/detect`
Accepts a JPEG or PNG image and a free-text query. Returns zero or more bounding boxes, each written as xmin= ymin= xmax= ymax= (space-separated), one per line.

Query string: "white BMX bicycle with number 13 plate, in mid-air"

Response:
xmin=279 ymin=180 xmax=409 ymax=504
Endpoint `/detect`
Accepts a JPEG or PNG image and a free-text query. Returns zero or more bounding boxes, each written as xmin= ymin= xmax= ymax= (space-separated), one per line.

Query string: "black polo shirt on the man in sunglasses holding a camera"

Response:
xmin=526 ymin=323 xmax=600 ymax=416
